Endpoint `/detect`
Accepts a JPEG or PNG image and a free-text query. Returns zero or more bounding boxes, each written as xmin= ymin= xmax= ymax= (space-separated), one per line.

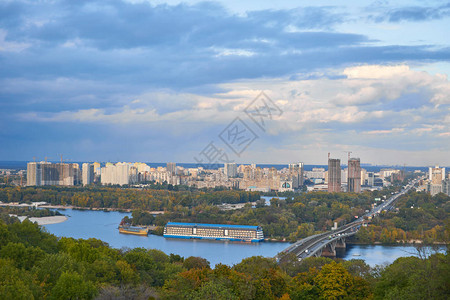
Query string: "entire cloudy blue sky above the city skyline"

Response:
xmin=0 ymin=0 xmax=450 ymax=166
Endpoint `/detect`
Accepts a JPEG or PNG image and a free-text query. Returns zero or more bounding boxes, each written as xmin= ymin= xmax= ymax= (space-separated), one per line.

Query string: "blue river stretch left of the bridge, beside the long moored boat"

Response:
xmin=45 ymin=209 xmax=289 ymax=266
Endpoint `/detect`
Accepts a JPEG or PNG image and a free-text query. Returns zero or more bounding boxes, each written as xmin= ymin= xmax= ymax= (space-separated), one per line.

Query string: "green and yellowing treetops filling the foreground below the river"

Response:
xmin=0 ymin=214 xmax=450 ymax=299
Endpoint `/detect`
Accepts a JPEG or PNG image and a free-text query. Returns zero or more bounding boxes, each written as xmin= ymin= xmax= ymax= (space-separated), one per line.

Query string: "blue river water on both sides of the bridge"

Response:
xmin=45 ymin=209 xmax=442 ymax=266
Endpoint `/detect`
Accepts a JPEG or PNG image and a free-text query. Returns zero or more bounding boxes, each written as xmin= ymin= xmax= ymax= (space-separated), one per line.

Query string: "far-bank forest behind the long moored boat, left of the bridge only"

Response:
xmin=0 ymin=186 xmax=398 ymax=240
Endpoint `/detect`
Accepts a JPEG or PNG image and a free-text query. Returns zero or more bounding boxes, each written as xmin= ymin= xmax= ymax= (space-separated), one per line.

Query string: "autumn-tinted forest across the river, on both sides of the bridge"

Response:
xmin=0 ymin=186 xmax=450 ymax=243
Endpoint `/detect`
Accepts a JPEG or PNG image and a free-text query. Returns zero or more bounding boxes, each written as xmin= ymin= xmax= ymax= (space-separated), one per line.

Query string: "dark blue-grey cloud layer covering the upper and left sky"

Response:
xmin=0 ymin=0 xmax=450 ymax=164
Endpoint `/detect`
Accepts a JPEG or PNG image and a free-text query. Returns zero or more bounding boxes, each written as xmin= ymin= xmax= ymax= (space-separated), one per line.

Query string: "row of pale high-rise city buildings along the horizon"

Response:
xmin=22 ymin=159 xmax=450 ymax=196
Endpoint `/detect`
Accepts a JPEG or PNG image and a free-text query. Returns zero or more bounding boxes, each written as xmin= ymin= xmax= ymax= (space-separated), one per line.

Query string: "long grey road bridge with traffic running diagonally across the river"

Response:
xmin=276 ymin=180 xmax=418 ymax=261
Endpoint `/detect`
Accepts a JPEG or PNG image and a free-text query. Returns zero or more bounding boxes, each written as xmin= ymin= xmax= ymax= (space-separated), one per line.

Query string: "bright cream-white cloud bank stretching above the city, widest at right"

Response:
xmin=14 ymin=65 xmax=450 ymax=162
